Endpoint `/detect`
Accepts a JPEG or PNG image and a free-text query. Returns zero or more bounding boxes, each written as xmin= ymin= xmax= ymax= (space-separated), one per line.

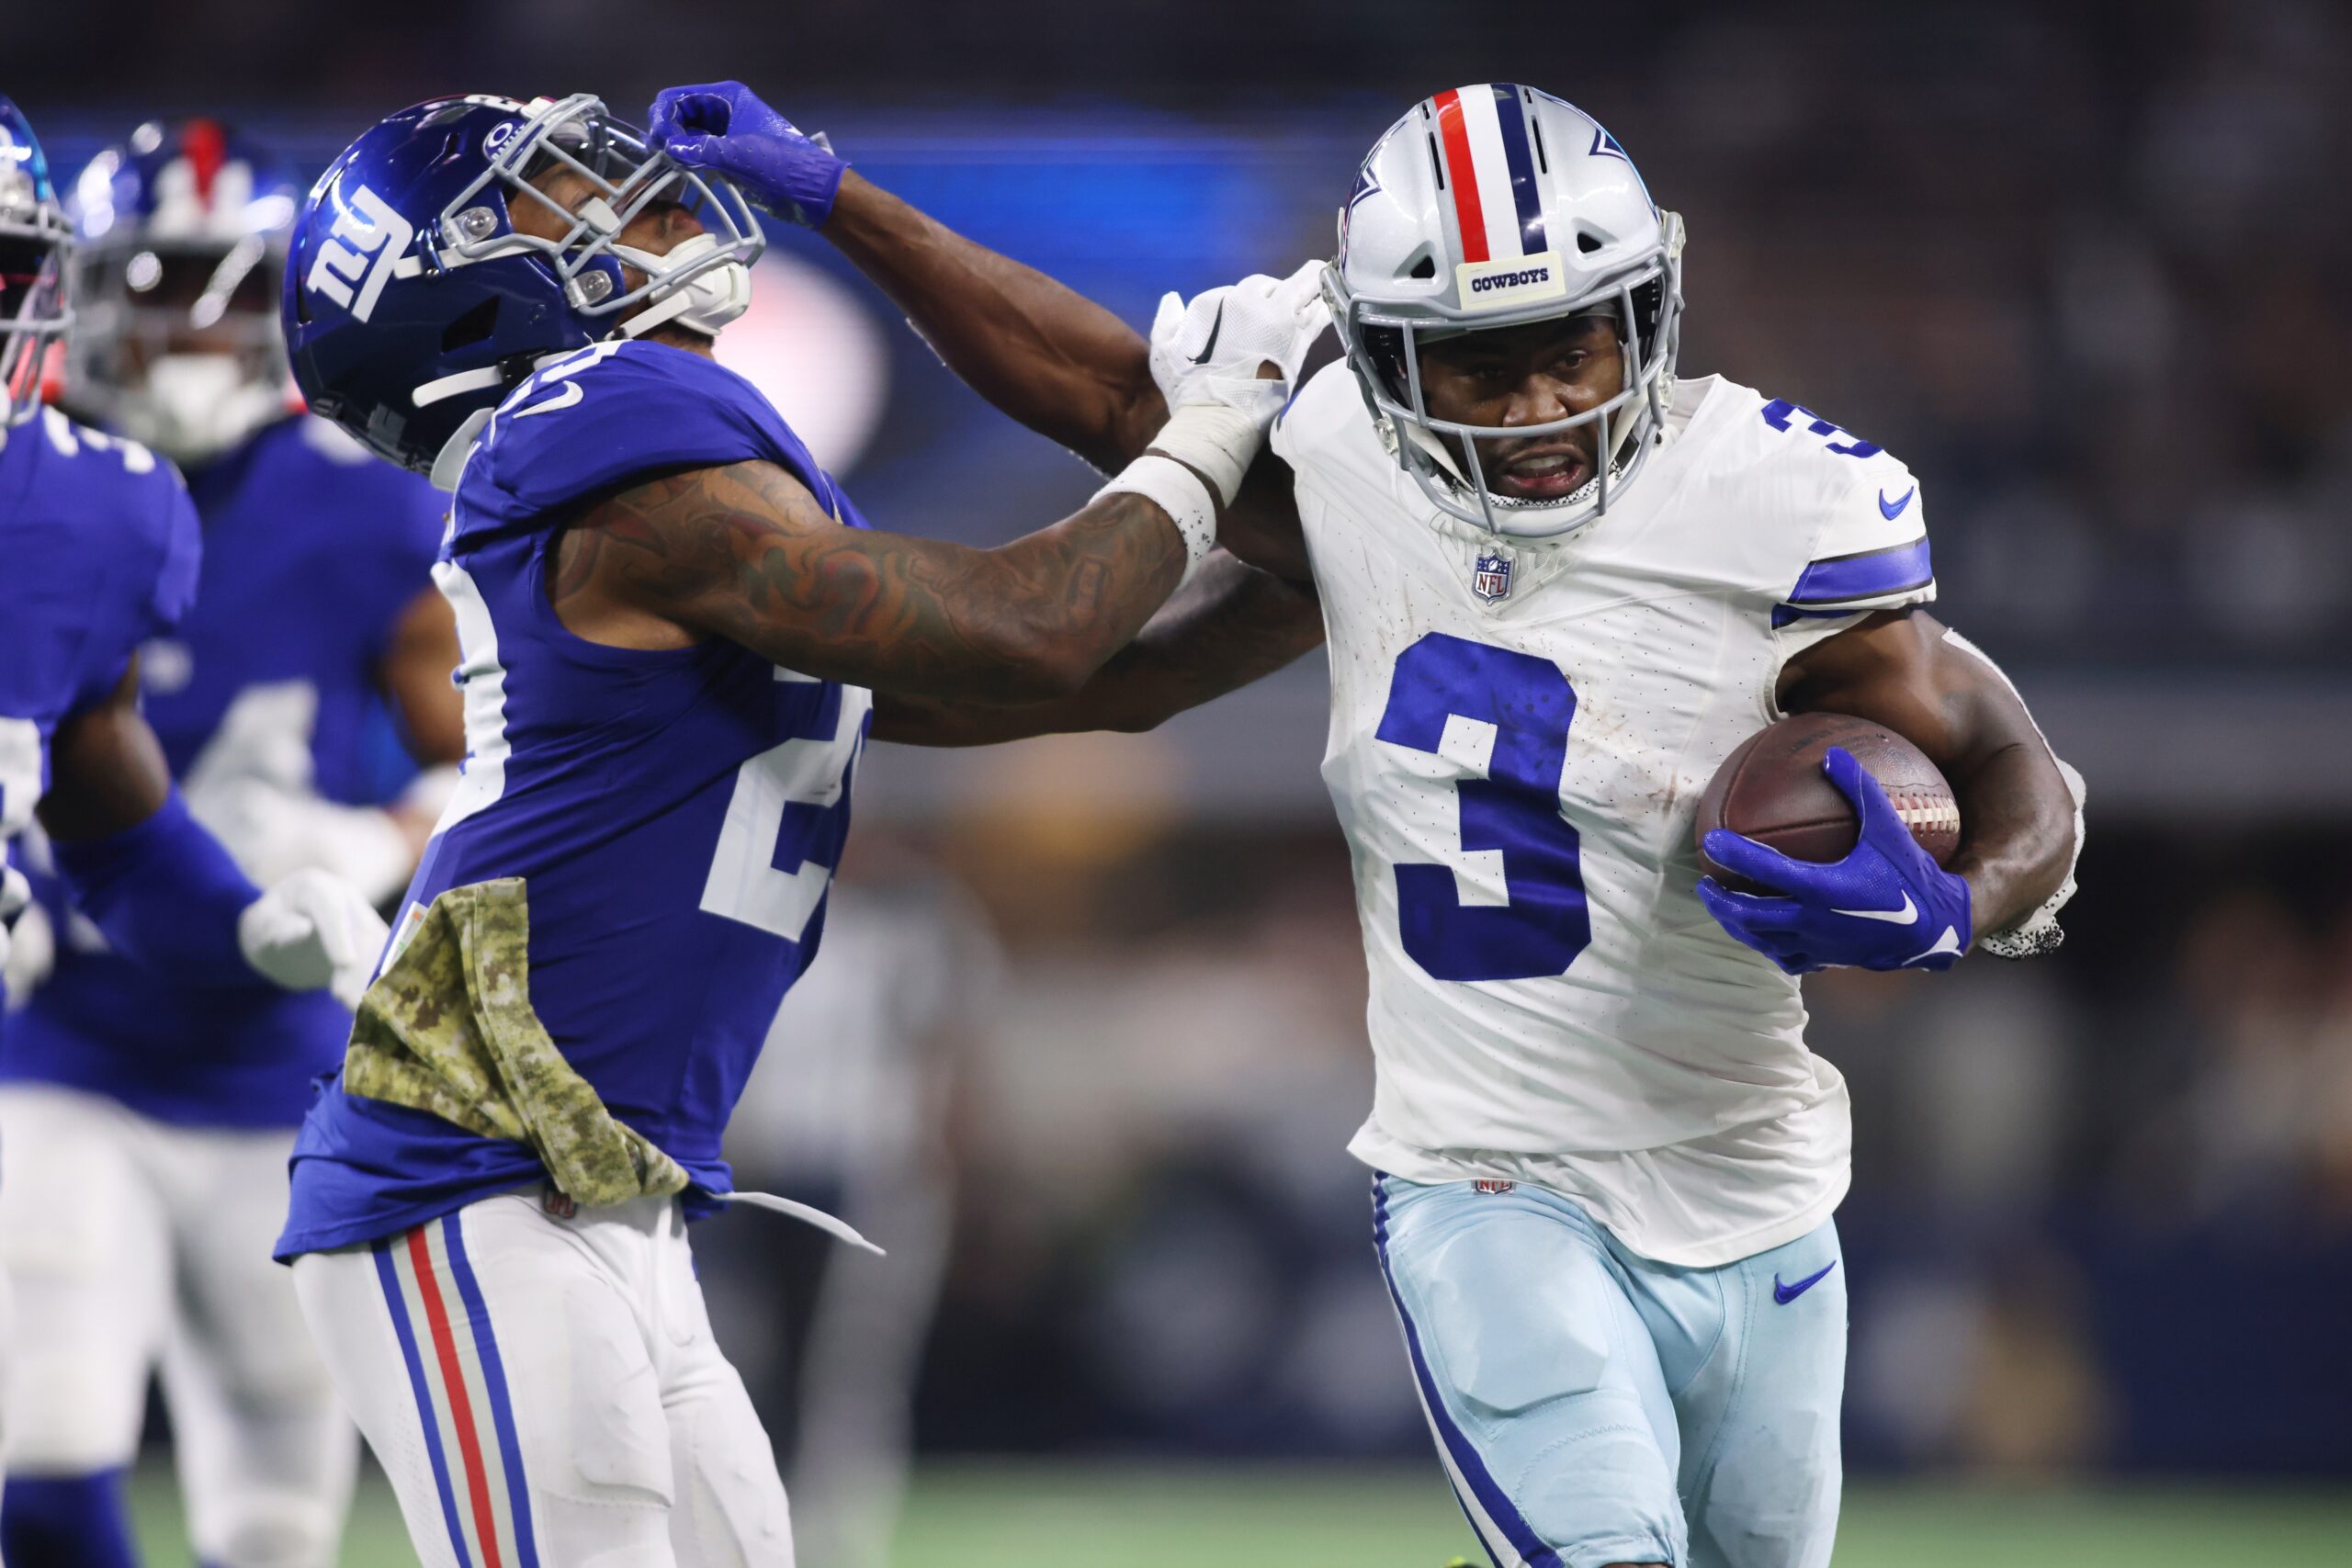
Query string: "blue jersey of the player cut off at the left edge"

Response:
xmin=0 ymin=409 xmax=202 ymax=1029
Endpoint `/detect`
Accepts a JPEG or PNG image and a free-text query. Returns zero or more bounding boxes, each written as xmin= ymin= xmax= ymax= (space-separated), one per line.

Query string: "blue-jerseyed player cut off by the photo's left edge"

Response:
xmin=0 ymin=98 xmax=397 ymax=1563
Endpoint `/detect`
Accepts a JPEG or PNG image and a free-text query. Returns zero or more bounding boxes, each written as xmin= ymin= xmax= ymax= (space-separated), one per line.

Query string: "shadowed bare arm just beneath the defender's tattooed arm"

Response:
xmin=873 ymin=550 xmax=1322 ymax=745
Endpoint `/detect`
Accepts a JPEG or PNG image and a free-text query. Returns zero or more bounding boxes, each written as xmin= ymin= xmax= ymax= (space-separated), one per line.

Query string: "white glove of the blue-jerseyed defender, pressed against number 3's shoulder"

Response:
xmin=1150 ymin=261 xmax=1331 ymax=505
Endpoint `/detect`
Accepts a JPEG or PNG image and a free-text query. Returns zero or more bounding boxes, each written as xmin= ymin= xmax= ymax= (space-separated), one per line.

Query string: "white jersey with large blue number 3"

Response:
xmin=1272 ymin=365 xmax=1936 ymax=1267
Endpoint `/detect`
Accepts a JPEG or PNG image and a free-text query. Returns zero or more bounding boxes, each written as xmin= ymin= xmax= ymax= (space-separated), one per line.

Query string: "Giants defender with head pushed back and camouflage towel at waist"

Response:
xmin=277 ymin=94 xmax=1312 ymax=1568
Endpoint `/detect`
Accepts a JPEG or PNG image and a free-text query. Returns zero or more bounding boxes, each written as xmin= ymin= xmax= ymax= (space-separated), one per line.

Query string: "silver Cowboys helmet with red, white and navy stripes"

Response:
xmin=1327 ymin=83 xmax=1681 ymax=538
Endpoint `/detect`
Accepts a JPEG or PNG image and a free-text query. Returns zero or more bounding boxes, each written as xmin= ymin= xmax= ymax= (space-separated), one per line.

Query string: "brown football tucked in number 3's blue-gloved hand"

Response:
xmin=1698 ymin=712 xmax=1959 ymax=894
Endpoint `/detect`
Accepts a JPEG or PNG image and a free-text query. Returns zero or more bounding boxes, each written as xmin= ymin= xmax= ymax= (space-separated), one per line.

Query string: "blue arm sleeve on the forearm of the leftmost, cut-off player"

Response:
xmin=51 ymin=787 xmax=268 ymax=985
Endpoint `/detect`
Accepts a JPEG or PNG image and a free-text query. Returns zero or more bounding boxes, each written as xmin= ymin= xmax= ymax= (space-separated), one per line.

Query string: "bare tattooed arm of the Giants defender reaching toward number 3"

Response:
xmin=548 ymin=463 xmax=1185 ymax=703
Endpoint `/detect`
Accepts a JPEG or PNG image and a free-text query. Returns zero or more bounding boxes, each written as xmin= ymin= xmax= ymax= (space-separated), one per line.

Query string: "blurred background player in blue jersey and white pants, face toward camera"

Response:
xmin=0 ymin=120 xmax=463 ymax=1568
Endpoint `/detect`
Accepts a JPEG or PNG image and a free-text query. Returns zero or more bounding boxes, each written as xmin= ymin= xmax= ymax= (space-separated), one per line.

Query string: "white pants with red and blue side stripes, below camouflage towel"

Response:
xmin=294 ymin=1190 xmax=793 ymax=1568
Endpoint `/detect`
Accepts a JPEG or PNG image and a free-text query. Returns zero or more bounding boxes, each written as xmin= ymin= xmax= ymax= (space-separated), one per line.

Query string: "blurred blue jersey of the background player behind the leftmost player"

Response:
xmin=0 ymin=419 xmax=447 ymax=1128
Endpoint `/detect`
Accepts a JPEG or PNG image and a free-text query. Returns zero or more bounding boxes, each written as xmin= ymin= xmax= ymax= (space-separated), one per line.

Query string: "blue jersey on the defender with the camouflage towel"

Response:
xmin=277 ymin=344 xmax=873 ymax=1258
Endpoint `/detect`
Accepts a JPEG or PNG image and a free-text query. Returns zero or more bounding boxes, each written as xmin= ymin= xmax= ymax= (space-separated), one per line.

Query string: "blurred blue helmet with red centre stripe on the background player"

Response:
xmin=66 ymin=120 xmax=301 ymax=463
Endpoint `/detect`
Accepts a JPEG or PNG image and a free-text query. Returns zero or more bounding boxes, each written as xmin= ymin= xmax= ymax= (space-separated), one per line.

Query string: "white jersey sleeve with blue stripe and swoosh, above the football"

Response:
xmin=1771 ymin=454 xmax=1936 ymax=651
